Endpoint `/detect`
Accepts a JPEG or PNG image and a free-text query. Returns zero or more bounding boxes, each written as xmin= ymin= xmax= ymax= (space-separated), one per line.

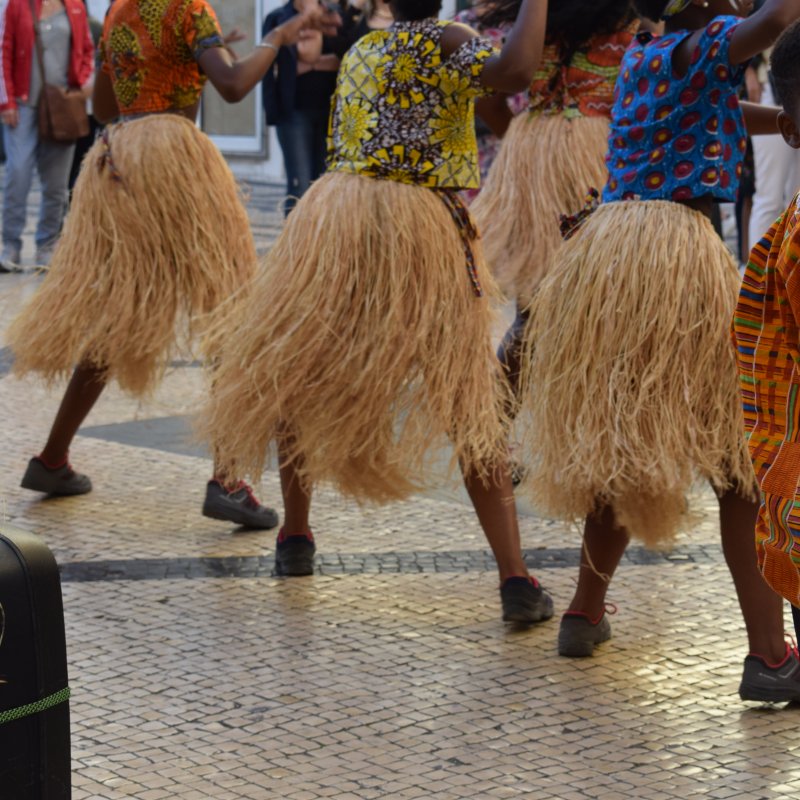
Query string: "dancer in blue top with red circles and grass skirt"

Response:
xmin=523 ymin=0 xmax=800 ymax=700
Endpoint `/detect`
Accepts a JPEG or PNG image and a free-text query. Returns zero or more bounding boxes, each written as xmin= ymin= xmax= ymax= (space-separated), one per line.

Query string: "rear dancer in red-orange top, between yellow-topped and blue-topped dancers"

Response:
xmin=472 ymin=0 xmax=639 ymax=391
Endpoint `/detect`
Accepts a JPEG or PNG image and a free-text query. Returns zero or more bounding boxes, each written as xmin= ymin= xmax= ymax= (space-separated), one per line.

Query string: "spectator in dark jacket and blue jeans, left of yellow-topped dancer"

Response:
xmin=262 ymin=0 xmax=352 ymax=215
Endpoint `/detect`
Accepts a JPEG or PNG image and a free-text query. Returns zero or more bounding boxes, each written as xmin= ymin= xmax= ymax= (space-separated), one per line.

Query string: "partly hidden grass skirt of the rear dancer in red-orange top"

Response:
xmin=471 ymin=113 xmax=609 ymax=305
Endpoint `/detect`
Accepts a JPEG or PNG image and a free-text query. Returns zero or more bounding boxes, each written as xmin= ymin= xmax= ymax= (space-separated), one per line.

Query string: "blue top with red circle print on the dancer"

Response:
xmin=603 ymin=17 xmax=747 ymax=202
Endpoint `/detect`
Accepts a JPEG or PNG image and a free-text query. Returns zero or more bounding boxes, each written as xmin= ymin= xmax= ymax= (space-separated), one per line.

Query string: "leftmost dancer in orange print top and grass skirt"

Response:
xmin=8 ymin=0 xmax=340 ymax=528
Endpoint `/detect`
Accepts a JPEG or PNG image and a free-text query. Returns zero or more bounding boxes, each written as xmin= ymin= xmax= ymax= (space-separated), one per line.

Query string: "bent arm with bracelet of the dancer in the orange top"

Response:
xmin=197 ymin=5 xmax=341 ymax=103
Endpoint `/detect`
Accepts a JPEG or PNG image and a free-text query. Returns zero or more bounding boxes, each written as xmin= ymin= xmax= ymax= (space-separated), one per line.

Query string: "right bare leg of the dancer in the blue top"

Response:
xmin=719 ymin=490 xmax=786 ymax=663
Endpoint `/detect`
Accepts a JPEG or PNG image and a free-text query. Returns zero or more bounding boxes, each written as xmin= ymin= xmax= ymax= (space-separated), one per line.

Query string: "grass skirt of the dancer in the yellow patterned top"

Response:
xmin=200 ymin=173 xmax=508 ymax=502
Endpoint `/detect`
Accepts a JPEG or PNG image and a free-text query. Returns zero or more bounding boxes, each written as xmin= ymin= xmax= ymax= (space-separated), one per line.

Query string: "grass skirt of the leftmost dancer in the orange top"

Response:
xmin=8 ymin=114 xmax=256 ymax=394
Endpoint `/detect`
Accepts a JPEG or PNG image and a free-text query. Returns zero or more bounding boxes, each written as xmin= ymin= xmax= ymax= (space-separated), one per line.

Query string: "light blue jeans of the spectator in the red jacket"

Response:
xmin=3 ymin=106 xmax=75 ymax=251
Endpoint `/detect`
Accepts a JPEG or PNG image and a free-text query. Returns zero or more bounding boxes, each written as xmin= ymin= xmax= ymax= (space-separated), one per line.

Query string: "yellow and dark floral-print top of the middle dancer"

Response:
xmin=328 ymin=19 xmax=495 ymax=189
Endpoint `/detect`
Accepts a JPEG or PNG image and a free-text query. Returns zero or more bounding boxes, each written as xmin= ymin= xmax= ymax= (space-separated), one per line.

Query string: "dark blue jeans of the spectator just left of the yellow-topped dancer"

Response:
xmin=275 ymin=107 xmax=329 ymax=216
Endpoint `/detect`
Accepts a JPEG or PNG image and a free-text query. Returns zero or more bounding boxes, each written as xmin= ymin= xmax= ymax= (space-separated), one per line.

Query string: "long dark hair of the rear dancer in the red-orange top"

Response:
xmin=478 ymin=0 xmax=633 ymax=64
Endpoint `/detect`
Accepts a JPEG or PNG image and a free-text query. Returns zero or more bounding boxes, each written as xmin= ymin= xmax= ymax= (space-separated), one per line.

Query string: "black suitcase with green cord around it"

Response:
xmin=0 ymin=524 xmax=72 ymax=800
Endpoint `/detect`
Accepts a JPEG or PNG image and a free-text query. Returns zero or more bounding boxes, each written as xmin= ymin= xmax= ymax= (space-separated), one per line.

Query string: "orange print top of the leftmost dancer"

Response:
xmin=98 ymin=0 xmax=224 ymax=115
